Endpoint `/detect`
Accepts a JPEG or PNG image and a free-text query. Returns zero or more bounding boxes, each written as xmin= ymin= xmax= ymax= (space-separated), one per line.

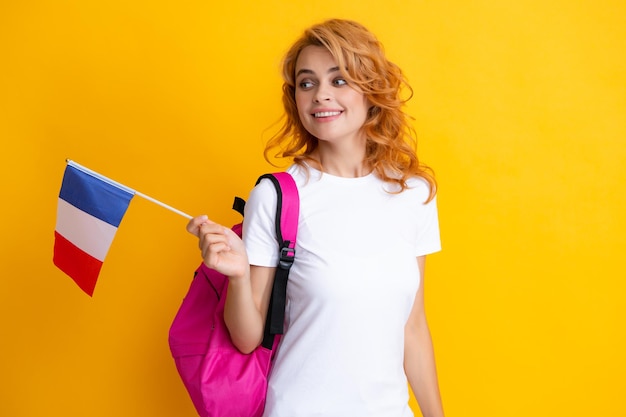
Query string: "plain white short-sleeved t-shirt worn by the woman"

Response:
xmin=243 ymin=165 xmax=440 ymax=417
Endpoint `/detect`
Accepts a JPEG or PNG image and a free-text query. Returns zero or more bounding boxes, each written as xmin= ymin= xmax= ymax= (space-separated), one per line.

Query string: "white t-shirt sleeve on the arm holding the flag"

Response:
xmin=243 ymin=179 xmax=278 ymax=267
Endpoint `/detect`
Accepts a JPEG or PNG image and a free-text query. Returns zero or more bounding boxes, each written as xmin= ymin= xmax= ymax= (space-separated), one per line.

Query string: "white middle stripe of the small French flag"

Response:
xmin=56 ymin=198 xmax=117 ymax=262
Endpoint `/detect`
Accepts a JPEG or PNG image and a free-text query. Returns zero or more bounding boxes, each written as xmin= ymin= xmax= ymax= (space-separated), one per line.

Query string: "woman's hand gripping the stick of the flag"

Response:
xmin=187 ymin=216 xmax=250 ymax=278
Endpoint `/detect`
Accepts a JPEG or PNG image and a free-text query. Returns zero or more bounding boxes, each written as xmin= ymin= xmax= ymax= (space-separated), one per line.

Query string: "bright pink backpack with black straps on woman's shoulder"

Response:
xmin=169 ymin=172 xmax=300 ymax=417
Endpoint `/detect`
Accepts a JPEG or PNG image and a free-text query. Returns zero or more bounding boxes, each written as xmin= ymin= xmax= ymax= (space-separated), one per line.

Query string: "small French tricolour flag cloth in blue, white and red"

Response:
xmin=53 ymin=161 xmax=135 ymax=296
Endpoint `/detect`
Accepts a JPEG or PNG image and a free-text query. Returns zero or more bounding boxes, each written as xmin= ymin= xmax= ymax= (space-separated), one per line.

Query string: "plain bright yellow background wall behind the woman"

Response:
xmin=0 ymin=0 xmax=626 ymax=417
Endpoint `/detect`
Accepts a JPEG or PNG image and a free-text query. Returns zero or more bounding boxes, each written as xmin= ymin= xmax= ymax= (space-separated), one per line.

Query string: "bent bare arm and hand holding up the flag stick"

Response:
xmin=187 ymin=216 xmax=275 ymax=353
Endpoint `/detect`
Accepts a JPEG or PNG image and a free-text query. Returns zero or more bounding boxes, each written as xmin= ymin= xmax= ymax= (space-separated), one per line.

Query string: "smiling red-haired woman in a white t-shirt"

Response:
xmin=187 ymin=19 xmax=443 ymax=417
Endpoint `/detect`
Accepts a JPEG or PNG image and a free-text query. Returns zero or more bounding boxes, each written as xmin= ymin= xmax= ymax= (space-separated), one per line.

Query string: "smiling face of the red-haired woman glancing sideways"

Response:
xmin=295 ymin=46 xmax=369 ymax=146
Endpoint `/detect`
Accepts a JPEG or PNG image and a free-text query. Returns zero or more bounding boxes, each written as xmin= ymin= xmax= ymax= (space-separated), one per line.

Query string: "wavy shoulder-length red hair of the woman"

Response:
xmin=265 ymin=19 xmax=436 ymax=201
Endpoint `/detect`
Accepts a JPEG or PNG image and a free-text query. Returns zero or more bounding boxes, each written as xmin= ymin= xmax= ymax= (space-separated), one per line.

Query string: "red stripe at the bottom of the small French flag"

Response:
xmin=52 ymin=231 xmax=102 ymax=296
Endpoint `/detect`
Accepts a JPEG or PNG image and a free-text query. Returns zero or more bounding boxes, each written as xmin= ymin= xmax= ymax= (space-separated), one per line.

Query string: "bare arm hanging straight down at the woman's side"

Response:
xmin=404 ymin=256 xmax=444 ymax=417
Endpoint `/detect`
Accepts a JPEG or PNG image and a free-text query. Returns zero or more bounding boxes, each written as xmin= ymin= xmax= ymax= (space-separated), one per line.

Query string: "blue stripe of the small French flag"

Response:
xmin=59 ymin=165 xmax=133 ymax=227
